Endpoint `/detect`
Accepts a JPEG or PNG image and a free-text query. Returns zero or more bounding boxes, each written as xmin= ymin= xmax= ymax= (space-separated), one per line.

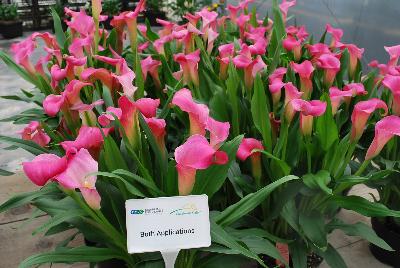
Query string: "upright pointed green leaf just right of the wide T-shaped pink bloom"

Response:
xmin=316 ymin=94 xmax=339 ymax=152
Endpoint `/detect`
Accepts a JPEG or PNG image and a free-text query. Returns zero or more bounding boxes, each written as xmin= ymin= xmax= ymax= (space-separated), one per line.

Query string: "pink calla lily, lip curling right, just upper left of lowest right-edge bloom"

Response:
xmin=350 ymin=98 xmax=388 ymax=142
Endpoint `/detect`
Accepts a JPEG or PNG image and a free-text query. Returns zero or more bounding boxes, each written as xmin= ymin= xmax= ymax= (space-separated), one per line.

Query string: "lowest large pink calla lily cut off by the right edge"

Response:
xmin=365 ymin=115 xmax=400 ymax=161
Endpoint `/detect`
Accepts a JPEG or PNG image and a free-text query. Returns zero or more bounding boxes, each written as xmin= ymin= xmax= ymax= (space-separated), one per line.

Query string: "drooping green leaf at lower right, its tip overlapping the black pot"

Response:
xmin=327 ymin=219 xmax=394 ymax=251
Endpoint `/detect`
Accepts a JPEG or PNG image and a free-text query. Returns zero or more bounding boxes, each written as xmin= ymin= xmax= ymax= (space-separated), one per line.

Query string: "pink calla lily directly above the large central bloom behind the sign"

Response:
xmin=171 ymin=88 xmax=209 ymax=135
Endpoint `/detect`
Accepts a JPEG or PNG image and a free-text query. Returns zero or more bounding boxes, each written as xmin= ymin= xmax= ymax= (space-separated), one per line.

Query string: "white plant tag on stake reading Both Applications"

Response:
xmin=125 ymin=195 xmax=211 ymax=268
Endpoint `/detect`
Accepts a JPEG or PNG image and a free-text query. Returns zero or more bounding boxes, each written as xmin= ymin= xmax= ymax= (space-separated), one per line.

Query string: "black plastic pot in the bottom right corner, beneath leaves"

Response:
xmin=369 ymin=217 xmax=400 ymax=267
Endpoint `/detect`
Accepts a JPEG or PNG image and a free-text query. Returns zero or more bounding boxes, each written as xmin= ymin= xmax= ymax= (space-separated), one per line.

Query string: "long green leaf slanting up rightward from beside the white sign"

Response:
xmin=216 ymin=175 xmax=299 ymax=226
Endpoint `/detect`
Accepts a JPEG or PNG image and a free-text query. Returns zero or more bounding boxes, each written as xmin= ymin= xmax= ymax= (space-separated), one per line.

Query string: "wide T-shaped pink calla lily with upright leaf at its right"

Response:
xmin=285 ymin=99 xmax=326 ymax=136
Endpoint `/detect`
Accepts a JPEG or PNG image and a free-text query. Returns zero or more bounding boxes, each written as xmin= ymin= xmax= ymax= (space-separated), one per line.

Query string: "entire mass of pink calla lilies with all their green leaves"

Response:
xmin=0 ymin=0 xmax=400 ymax=268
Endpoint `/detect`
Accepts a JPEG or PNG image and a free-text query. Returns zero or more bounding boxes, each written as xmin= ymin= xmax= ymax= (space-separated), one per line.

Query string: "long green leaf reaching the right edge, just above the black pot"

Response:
xmin=330 ymin=195 xmax=400 ymax=217
